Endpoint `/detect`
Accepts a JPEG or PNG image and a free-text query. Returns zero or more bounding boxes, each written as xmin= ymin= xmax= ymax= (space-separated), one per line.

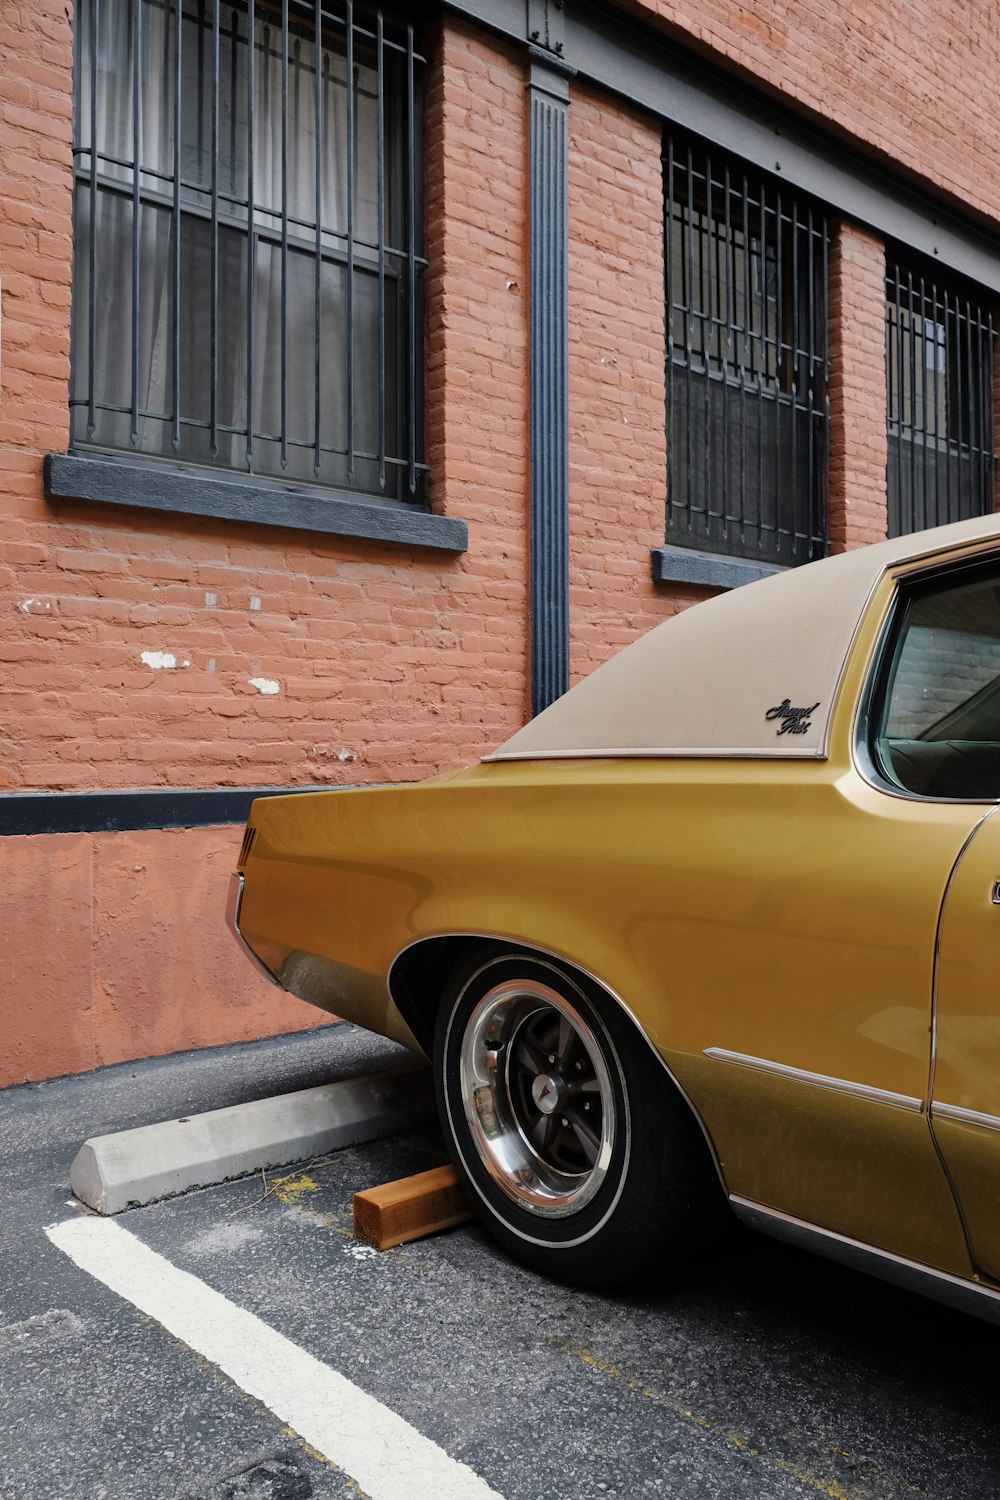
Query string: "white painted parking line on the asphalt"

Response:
xmin=46 ymin=1217 xmax=502 ymax=1500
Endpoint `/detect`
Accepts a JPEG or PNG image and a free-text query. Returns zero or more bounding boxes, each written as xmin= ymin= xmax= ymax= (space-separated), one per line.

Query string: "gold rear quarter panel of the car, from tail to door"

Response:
xmin=243 ymin=761 xmax=973 ymax=1271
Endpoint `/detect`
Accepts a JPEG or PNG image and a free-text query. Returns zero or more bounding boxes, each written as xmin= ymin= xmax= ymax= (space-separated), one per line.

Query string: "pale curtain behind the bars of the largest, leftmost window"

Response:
xmin=73 ymin=0 xmax=394 ymax=488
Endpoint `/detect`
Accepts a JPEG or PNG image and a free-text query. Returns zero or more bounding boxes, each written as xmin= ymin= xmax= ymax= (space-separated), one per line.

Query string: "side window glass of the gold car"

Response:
xmin=871 ymin=567 xmax=1000 ymax=801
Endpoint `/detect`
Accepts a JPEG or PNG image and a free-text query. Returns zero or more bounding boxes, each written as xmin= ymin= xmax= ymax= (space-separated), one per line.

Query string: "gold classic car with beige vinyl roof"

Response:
xmin=229 ymin=518 xmax=1000 ymax=1317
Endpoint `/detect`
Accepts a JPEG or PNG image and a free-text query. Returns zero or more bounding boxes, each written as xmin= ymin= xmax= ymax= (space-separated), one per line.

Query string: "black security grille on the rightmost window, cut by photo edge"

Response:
xmin=886 ymin=261 xmax=994 ymax=537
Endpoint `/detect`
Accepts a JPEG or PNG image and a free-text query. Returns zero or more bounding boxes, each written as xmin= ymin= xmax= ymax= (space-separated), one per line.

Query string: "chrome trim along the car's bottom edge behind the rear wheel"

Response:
xmin=729 ymin=1194 xmax=1000 ymax=1323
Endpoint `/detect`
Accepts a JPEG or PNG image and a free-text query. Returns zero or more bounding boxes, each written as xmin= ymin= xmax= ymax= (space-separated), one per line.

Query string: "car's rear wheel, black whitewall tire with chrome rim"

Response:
xmin=435 ymin=948 xmax=727 ymax=1287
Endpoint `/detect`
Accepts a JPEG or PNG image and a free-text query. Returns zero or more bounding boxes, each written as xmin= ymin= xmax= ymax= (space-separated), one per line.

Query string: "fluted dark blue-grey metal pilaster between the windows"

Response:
xmin=529 ymin=60 xmax=570 ymax=729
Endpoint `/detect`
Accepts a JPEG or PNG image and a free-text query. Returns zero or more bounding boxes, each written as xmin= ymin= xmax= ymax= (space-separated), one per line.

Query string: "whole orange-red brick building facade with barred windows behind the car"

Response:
xmin=0 ymin=0 xmax=1000 ymax=1086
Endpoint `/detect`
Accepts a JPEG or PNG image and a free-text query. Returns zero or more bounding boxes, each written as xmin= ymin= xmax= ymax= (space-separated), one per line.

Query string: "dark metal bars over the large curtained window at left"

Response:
xmin=70 ymin=0 xmax=426 ymax=506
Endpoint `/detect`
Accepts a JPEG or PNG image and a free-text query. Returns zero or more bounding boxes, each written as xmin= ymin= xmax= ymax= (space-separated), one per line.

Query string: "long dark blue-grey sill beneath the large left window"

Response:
xmin=45 ymin=453 xmax=469 ymax=552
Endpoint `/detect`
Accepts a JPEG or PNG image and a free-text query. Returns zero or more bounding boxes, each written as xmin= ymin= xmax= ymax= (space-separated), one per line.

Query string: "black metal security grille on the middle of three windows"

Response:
xmin=664 ymin=140 xmax=829 ymax=564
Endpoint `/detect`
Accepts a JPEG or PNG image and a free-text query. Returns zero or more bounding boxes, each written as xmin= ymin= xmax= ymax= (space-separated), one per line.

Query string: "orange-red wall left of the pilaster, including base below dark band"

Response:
xmin=0 ymin=0 xmax=539 ymax=1086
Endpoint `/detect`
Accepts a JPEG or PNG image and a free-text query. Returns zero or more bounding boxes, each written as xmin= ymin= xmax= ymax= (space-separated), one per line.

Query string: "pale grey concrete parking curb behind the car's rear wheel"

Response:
xmin=69 ymin=1064 xmax=435 ymax=1214
